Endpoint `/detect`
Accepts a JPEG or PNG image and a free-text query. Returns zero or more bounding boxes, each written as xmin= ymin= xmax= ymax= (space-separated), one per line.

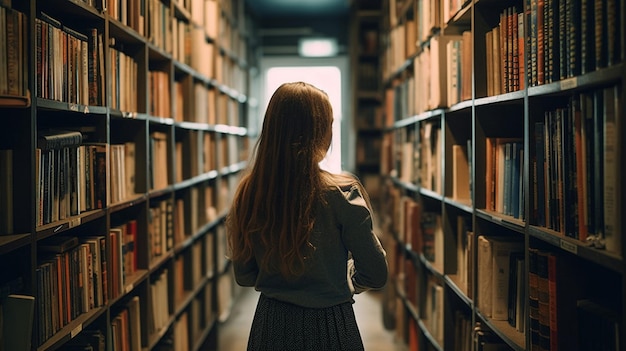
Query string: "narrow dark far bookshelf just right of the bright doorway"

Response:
xmin=350 ymin=0 xmax=383 ymax=209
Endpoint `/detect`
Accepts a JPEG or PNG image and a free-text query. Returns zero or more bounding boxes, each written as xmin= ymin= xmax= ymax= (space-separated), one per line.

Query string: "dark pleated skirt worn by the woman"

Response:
xmin=248 ymin=294 xmax=364 ymax=351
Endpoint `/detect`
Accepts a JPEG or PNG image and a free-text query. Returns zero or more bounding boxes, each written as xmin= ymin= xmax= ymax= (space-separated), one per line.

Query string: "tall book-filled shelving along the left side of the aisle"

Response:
xmin=0 ymin=0 xmax=252 ymax=351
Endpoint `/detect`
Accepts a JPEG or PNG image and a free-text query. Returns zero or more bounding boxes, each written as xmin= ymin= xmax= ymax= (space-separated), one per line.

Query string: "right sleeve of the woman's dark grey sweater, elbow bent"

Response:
xmin=337 ymin=187 xmax=388 ymax=293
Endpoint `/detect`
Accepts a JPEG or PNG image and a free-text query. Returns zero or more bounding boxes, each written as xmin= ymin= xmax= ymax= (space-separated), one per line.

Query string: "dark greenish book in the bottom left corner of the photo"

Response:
xmin=0 ymin=294 xmax=35 ymax=351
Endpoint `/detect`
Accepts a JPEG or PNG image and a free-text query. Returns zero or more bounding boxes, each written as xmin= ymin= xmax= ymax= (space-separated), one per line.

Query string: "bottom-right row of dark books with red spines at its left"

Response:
xmin=528 ymin=248 xmax=622 ymax=351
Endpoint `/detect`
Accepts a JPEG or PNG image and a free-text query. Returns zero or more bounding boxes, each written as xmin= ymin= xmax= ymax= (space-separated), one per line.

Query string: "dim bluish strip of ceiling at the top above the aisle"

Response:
xmin=245 ymin=0 xmax=351 ymax=19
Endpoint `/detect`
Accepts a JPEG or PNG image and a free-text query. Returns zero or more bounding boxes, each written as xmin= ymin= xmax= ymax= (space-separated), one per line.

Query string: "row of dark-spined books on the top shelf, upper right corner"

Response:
xmin=526 ymin=0 xmax=626 ymax=86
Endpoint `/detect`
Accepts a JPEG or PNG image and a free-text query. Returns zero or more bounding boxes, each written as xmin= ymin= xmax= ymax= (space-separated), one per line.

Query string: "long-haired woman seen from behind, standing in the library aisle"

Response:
xmin=227 ymin=82 xmax=388 ymax=350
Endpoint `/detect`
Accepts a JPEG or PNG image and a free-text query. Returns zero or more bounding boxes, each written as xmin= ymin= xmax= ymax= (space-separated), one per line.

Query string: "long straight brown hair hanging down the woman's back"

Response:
xmin=226 ymin=82 xmax=342 ymax=277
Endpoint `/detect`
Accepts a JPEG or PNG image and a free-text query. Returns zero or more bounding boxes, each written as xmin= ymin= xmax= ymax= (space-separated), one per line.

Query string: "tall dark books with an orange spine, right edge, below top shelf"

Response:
xmin=532 ymin=86 xmax=621 ymax=252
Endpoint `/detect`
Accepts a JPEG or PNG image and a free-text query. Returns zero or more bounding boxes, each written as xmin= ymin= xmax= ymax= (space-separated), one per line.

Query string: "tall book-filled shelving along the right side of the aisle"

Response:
xmin=380 ymin=0 xmax=626 ymax=351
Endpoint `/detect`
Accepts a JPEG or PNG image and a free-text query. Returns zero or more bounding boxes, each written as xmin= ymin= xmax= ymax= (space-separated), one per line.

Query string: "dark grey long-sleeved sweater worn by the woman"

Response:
xmin=233 ymin=186 xmax=388 ymax=308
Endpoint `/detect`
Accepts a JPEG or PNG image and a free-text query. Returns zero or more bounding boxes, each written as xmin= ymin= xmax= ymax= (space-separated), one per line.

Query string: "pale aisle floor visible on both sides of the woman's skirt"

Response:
xmin=212 ymin=288 xmax=407 ymax=351
